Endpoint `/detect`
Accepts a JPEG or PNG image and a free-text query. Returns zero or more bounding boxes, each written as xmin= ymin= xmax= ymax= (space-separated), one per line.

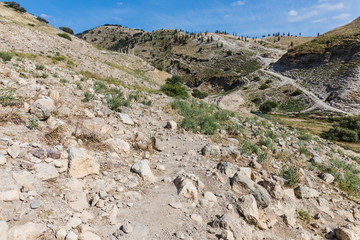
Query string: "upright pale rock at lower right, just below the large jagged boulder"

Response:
xmin=237 ymin=194 xmax=259 ymax=225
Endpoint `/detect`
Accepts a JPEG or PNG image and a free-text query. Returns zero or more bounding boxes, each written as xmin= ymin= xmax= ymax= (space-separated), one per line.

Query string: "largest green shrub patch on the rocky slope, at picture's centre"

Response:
xmin=171 ymin=100 xmax=237 ymax=135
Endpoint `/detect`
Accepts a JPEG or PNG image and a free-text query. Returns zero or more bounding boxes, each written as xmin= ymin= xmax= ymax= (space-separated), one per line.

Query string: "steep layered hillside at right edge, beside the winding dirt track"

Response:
xmin=274 ymin=18 xmax=360 ymax=114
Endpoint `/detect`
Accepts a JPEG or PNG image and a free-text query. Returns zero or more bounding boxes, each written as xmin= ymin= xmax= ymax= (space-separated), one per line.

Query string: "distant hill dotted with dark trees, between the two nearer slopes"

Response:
xmin=78 ymin=25 xmax=281 ymax=92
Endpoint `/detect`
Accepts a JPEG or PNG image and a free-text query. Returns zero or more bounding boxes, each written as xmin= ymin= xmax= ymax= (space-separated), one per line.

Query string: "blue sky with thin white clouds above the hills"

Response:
xmin=17 ymin=0 xmax=360 ymax=36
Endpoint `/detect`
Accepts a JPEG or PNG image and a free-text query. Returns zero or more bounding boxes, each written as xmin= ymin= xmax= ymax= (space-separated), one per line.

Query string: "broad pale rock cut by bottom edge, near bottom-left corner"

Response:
xmin=7 ymin=222 xmax=46 ymax=240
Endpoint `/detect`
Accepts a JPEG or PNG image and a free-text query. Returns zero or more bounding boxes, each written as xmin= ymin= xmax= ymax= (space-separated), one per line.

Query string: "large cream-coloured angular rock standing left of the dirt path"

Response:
xmin=68 ymin=147 xmax=100 ymax=178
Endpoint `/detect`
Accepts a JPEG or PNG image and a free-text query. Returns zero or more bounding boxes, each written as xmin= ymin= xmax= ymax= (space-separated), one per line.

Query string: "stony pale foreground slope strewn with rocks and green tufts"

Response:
xmin=0 ymin=3 xmax=360 ymax=240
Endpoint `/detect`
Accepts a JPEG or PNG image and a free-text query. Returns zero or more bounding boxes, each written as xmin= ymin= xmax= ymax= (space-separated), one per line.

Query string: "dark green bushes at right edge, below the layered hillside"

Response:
xmin=321 ymin=117 xmax=360 ymax=143
